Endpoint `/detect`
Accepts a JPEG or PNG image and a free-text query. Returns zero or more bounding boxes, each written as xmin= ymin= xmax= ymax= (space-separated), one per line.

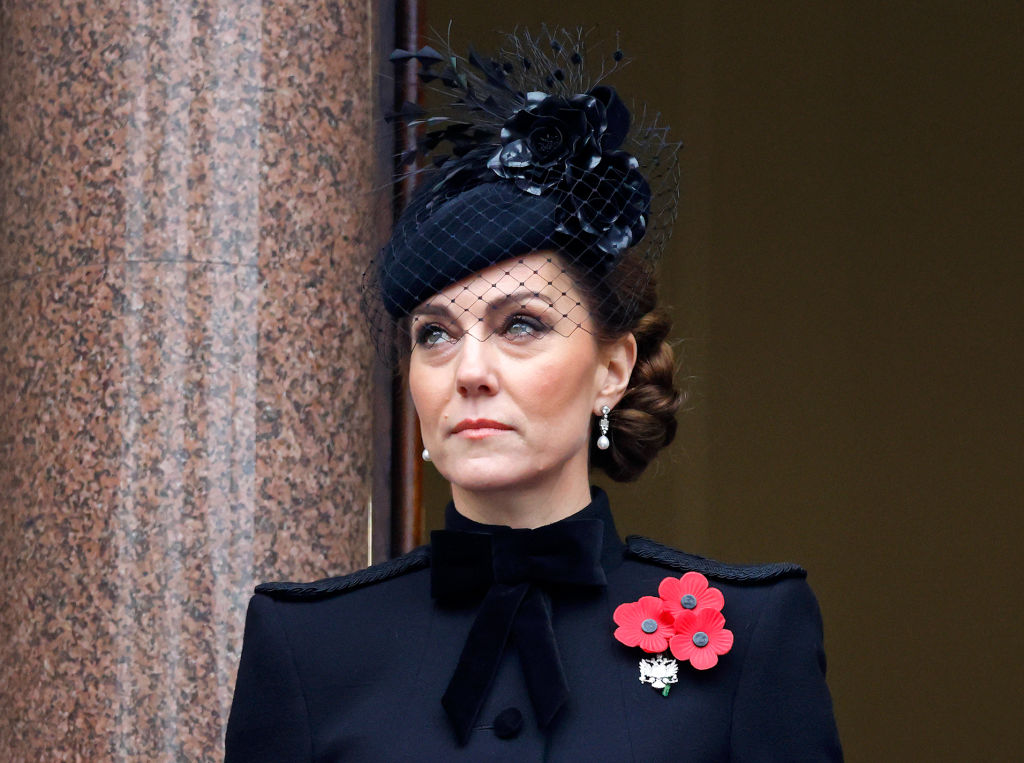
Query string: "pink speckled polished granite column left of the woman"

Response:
xmin=0 ymin=0 xmax=389 ymax=762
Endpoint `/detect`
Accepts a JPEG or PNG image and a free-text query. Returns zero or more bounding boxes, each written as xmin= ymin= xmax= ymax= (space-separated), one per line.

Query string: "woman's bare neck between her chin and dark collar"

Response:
xmin=452 ymin=473 xmax=590 ymax=529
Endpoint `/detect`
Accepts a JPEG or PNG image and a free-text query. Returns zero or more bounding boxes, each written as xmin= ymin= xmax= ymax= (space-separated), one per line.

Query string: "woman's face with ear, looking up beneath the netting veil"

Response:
xmin=409 ymin=253 xmax=632 ymax=492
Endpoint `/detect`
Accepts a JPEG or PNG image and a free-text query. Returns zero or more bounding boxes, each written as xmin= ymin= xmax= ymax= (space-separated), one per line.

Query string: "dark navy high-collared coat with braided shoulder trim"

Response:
xmin=226 ymin=491 xmax=842 ymax=763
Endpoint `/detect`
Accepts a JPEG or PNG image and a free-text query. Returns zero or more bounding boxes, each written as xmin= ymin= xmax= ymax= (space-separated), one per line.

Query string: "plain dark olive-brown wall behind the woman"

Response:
xmin=417 ymin=0 xmax=1024 ymax=761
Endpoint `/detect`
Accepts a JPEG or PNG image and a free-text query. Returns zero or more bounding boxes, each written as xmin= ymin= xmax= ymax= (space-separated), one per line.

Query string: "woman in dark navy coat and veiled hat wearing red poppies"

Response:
xmin=227 ymin=26 xmax=841 ymax=761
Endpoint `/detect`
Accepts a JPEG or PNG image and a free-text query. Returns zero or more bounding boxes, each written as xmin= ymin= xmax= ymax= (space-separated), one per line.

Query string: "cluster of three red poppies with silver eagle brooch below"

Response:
xmin=612 ymin=573 xmax=732 ymax=696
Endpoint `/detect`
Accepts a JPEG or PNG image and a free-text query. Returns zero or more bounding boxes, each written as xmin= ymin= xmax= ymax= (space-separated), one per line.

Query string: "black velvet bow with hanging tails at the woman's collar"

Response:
xmin=430 ymin=519 xmax=607 ymax=745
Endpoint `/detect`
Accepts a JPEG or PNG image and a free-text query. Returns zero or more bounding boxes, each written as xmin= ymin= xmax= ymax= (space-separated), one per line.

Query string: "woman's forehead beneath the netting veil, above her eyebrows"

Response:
xmin=413 ymin=252 xmax=586 ymax=323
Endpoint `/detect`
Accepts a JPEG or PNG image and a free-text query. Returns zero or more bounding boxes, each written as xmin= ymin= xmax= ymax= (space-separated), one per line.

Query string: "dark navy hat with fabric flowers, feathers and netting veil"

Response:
xmin=364 ymin=28 xmax=679 ymax=358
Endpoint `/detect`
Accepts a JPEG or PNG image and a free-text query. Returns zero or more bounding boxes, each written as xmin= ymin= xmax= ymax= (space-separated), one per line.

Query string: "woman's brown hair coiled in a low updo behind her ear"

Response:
xmin=569 ymin=258 xmax=684 ymax=482
